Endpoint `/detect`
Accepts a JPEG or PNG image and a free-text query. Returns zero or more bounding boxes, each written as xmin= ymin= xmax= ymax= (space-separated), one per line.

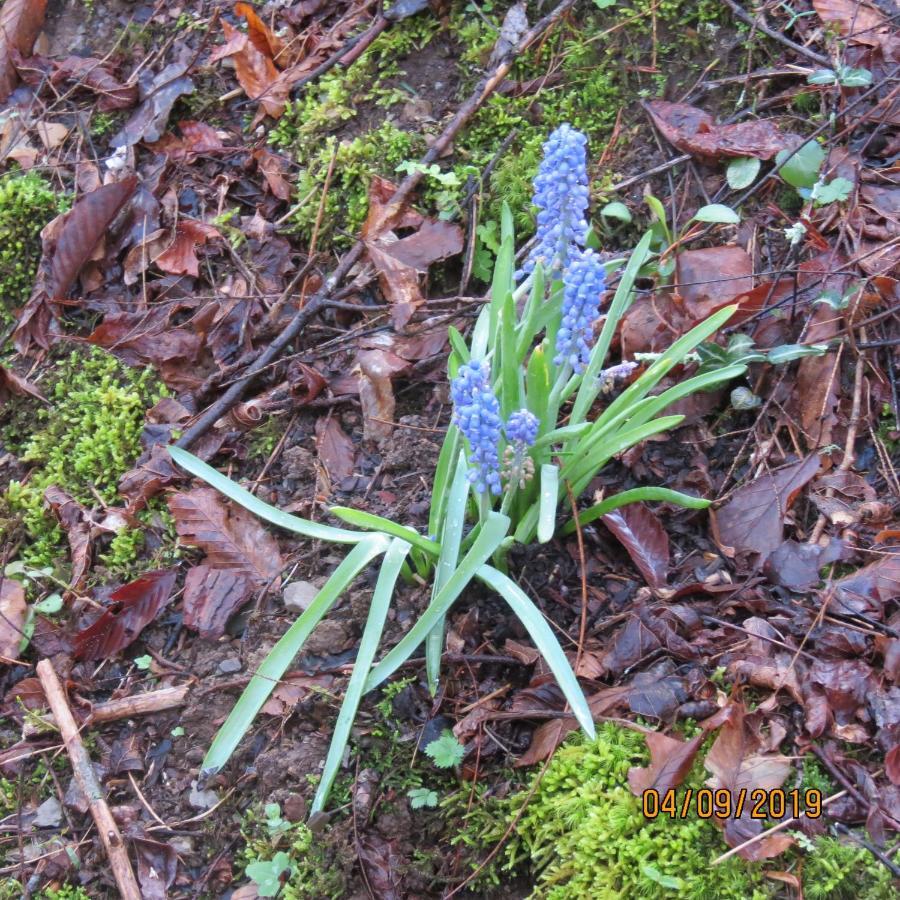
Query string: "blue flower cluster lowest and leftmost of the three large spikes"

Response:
xmin=450 ymin=359 xmax=502 ymax=494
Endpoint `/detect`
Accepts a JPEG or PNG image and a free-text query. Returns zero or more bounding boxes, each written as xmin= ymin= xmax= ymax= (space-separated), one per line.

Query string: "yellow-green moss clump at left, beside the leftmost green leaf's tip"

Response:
xmin=3 ymin=348 xmax=167 ymax=567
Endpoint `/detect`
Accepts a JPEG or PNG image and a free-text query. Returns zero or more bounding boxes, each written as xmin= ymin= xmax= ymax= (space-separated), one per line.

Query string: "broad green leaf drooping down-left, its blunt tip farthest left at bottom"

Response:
xmin=201 ymin=534 xmax=390 ymax=774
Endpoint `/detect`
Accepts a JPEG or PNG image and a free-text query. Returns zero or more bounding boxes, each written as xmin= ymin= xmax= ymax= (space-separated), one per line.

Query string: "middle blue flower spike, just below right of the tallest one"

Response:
xmin=554 ymin=250 xmax=606 ymax=373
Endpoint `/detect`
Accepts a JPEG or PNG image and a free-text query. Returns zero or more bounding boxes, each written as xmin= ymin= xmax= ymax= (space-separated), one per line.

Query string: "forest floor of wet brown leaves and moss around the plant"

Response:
xmin=0 ymin=0 xmax=900 ymax=900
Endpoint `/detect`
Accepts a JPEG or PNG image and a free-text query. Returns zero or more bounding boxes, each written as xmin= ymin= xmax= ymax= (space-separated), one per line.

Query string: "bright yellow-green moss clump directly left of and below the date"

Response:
xmin=506 ymin=724 xmax=771 ymax=900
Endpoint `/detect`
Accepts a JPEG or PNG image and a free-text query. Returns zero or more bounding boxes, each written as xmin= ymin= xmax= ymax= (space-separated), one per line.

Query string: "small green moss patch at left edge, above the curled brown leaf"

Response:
xmin=0 ymin=172 xmax=68 ymax=322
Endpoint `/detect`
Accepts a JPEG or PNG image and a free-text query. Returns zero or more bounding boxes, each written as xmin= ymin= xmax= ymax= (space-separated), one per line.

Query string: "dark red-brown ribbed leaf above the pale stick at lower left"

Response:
xmin=74 ymin=569 xmax=178 ymax=659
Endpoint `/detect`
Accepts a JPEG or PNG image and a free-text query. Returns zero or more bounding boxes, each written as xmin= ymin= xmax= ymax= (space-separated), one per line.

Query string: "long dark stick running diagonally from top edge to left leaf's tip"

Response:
xmin=175 ymin=0 xmax=575 ymax=448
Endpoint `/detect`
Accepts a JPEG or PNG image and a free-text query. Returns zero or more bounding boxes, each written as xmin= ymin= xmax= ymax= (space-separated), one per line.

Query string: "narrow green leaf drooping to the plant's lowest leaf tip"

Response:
xmin=310 ymin=538 xmax=411 ymax=813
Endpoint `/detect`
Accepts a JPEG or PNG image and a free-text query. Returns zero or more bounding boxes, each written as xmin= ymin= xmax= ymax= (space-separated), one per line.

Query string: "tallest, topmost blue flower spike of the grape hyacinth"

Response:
xmin=519 ymin=124 xmax=589 ymax=275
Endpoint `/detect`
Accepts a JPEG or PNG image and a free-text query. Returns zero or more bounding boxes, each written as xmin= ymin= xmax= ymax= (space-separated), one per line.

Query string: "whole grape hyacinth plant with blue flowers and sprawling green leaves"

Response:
xmin=170 ymin=125 xmax=746 ymax=812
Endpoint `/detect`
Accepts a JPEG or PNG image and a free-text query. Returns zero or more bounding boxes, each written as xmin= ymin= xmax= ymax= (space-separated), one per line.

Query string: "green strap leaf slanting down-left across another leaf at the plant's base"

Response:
xmin=366 ymin=512 xmax=509 ymax=691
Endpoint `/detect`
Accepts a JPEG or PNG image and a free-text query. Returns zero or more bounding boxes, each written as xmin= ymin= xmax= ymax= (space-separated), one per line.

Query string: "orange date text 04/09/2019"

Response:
xmin=641 ymin=788 xmax=822 ymax=819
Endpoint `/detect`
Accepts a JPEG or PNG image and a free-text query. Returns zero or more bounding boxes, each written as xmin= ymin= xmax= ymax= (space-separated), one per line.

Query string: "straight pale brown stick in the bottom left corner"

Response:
xmin=37 ymin=659 xmax=141 ymax=900
